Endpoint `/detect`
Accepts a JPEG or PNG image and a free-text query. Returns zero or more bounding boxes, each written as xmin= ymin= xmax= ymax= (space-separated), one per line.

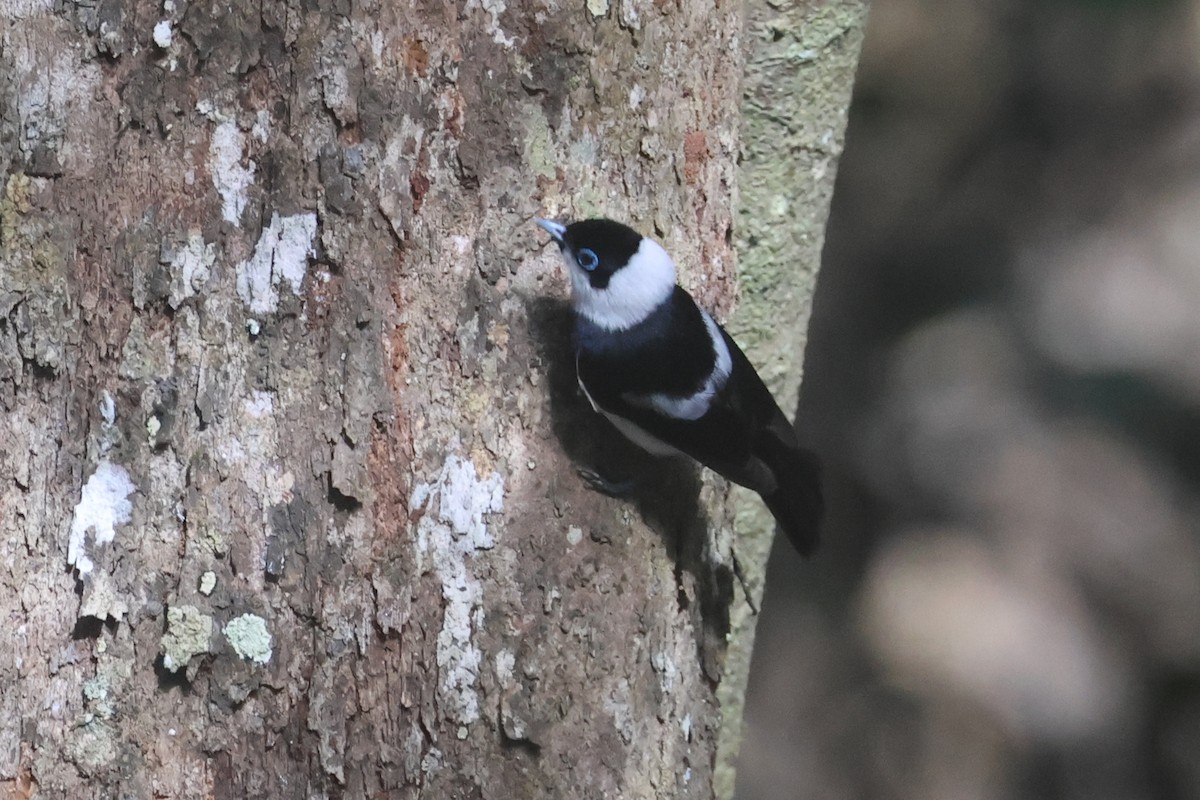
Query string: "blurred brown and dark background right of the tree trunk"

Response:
xmin=737 ymin=0 xmax=1200 ymax=800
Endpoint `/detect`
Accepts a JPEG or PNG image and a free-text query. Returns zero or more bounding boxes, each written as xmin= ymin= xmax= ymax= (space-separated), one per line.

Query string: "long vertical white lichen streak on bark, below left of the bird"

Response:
xmin=409 ymin=453 xmax=504 ymax=726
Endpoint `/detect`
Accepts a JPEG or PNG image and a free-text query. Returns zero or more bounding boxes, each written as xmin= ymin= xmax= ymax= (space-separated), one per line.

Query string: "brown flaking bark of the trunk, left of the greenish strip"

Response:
xmin=0 ymin=0 xmax=742 ymax=798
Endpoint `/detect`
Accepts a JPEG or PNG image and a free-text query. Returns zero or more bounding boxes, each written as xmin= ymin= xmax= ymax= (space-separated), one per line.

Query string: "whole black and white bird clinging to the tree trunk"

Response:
xmin=536 ymin=219 xmax=822 ymax=555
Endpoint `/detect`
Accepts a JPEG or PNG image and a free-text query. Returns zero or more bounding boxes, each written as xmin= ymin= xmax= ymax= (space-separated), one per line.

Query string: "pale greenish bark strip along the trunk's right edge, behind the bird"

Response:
xmin=718 ymin=0 xmax=866 ymax=798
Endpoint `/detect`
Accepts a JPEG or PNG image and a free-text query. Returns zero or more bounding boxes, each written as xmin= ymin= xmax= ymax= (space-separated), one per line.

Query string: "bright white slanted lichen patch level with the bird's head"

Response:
xmin=238 ymin=213 xmax=317 ymax=314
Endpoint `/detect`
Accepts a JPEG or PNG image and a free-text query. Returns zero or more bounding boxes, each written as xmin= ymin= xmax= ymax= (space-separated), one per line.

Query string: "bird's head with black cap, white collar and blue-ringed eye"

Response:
xmin=538 ymin=219 xmax=676 ymax=331
